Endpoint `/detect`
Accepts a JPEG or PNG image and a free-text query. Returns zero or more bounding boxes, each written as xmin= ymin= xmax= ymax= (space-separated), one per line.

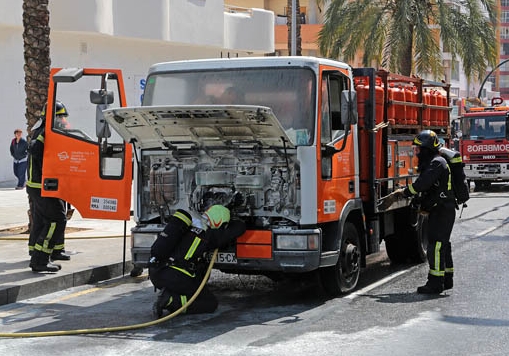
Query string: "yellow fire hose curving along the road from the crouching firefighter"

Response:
xmin=0 ymin=249 xmax=217 ymax=338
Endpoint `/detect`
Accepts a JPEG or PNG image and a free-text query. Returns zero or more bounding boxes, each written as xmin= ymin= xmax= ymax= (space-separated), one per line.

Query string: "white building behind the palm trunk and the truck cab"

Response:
xmin=0 ymin=0 xmax=274 ymax=188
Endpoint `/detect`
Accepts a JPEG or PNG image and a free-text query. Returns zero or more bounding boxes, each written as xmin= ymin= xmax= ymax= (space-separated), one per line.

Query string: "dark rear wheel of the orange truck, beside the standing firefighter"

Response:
xmin=385 ymin=208 xmax=428 ymax=263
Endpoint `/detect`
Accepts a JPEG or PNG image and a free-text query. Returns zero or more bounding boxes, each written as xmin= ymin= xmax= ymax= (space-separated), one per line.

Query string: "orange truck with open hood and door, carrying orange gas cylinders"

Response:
xmin=43 ymin=57 xmax=449 ymax=295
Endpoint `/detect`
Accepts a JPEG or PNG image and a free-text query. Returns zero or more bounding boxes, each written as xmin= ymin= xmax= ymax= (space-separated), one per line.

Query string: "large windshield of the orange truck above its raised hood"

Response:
xmin=143 ymin=67 xmax=316 ymax=145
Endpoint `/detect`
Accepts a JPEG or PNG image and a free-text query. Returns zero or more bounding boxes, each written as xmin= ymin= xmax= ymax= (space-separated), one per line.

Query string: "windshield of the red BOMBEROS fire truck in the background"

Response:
xmin=461 ymin=116 xmax=505 ymax=140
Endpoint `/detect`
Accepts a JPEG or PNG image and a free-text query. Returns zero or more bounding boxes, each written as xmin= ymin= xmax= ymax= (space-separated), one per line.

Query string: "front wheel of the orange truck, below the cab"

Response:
xmin=320 ymin=222 xmax=361 ymax=296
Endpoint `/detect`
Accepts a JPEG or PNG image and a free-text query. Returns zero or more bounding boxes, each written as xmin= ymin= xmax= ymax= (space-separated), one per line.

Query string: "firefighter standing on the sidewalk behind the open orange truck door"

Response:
xmin=27 ymin=101 xmax=71 ymax=272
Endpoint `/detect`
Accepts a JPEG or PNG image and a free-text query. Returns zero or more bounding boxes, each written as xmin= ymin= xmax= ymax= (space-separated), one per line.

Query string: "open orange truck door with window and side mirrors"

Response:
xmin=41 ymin=68 xmax=132 ymax=220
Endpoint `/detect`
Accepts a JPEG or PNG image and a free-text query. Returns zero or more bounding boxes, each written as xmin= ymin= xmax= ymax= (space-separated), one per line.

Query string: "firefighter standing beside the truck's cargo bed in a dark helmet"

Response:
xmin=388 ymin=130 xmax=456 ymax=294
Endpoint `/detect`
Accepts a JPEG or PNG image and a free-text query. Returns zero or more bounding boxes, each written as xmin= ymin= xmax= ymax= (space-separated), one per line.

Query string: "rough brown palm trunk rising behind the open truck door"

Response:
xmin=23 ymin=0 xmax=51 ymax=133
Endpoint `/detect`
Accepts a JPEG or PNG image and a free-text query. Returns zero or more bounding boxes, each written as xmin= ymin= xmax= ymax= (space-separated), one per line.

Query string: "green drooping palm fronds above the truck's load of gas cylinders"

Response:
xmin=317 ymin=0 xmax=497 ymax=80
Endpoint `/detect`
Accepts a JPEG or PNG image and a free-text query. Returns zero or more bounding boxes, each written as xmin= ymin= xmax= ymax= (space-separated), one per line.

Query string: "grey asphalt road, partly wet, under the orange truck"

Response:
xmin=0 ymin=185 xmax=509 ymax=356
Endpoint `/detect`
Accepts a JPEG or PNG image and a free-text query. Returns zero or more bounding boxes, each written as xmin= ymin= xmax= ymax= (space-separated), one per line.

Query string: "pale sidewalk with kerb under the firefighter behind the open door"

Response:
xmin=0 ymin=184 xmax=134 ymax=305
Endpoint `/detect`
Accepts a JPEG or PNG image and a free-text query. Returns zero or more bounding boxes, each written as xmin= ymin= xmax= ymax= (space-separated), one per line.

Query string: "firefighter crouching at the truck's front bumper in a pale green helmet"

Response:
xmin=149 ymin=205 xmax=246 ymax=318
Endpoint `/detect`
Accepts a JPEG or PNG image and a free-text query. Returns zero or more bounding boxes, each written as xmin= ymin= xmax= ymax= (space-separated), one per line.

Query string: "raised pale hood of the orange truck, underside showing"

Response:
xmin=103 ymin=105 xmax=295 ymax=149
